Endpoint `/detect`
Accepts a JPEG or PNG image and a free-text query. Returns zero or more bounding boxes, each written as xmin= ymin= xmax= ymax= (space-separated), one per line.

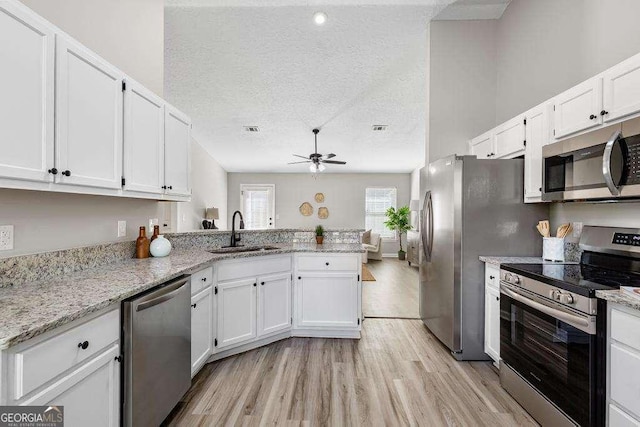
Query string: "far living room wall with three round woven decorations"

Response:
xmin=227 ymin=173 xmax=411 ymax=253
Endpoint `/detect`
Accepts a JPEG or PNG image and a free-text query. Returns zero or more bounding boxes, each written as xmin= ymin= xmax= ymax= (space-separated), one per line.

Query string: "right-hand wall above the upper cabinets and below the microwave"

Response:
xmin=485 ymin=0 xmax=640 ymax=227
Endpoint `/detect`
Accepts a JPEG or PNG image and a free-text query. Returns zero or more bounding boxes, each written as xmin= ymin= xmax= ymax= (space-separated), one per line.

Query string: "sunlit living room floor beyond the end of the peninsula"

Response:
xmin=362 ymin=258 xmax=420 ymax=319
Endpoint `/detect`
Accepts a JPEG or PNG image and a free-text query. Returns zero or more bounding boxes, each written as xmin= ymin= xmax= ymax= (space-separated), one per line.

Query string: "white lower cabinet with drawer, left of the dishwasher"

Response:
xmin=0 ymin=309 xmax=120 ymax=427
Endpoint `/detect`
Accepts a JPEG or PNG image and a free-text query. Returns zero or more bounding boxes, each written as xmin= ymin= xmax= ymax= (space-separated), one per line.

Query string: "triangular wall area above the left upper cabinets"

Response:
xmin=21 ymin=0 xmax=164 ymax=96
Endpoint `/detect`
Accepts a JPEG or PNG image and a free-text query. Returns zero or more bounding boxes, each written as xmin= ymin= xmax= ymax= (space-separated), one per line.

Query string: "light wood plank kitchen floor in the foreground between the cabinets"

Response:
xmin=165 ymin=319 xmax=535 ymax=427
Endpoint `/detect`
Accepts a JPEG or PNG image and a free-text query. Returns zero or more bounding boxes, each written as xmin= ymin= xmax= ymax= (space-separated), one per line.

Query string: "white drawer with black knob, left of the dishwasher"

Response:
xmin=10 ymin=310 xmax=120 ymax=399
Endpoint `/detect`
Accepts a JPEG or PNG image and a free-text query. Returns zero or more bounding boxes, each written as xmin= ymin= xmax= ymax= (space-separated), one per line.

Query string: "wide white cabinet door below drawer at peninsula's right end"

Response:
xmin=296 ymin=273 xmax=359 ymax=329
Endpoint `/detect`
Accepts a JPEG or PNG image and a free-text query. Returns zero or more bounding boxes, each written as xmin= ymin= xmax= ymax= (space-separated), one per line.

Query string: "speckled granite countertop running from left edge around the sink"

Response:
xmin=0 ymin=243 xmax=363 ymax=349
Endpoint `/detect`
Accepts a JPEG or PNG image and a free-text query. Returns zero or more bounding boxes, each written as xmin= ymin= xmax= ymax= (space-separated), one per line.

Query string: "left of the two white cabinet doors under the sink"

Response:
xmin=217 ymin=278 xmax=257 ymax=350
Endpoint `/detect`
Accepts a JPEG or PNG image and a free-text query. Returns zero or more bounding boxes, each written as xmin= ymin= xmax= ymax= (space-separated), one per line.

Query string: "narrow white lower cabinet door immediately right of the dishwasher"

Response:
xmin=191 ymin=287 xmax=213 ymax=376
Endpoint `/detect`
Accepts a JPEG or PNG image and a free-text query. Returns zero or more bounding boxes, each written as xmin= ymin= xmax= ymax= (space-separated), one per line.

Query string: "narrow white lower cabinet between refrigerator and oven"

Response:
xmin=484 ymin=264 xmax=500 ymax=364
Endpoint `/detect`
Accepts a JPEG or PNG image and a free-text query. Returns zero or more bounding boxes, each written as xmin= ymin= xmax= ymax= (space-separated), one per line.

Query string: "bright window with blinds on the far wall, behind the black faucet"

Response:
xmin=240 ymin=184 xmax=276 ymax=230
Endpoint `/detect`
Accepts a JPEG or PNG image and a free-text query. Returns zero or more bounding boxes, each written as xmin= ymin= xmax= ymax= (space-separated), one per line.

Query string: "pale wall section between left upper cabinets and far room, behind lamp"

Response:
xmin=175 ymin=140 xmax=227 ymax=231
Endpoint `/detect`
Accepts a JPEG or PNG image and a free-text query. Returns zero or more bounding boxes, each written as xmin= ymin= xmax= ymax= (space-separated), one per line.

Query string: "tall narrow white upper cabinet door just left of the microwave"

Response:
xmin=524 ymin=104 xmax=549 ymax=201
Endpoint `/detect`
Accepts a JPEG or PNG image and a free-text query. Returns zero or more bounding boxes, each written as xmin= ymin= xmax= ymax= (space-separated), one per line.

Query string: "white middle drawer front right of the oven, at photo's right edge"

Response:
xmin=610 ymin=343 xmax=640 ymax=417
